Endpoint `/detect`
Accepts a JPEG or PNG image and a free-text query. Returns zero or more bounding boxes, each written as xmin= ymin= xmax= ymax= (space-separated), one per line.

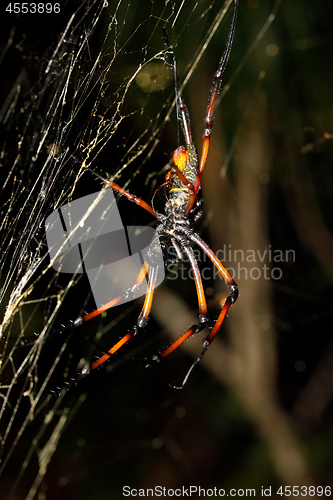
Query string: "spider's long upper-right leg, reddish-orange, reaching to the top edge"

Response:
xmin=186 ymin=0 xmax=238 ymax=214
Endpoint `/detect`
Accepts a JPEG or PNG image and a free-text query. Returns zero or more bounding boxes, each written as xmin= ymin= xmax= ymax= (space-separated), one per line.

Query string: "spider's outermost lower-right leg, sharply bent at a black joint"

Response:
xmin=170 ymin=233 xmax=238 ymax=389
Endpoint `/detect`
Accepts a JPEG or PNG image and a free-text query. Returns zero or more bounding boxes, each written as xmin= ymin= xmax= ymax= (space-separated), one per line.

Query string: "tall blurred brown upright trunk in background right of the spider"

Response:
xmin=224 ymin=89 xmax=312 ymax=485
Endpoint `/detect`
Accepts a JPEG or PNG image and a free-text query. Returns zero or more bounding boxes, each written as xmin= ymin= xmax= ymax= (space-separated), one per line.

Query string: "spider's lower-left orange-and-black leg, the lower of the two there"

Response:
xmin=88 ymin=263 xmax=158 ymax=372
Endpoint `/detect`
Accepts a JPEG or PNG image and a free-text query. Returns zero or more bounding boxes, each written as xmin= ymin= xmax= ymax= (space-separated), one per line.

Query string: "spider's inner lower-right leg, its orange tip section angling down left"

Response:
xmin=146 ymin=236 xmax=208 ymax=366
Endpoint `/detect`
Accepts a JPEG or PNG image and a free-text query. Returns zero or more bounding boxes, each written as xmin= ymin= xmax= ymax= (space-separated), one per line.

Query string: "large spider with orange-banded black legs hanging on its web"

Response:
xmin=67 ymin=0 xmax=238 ymax=388
